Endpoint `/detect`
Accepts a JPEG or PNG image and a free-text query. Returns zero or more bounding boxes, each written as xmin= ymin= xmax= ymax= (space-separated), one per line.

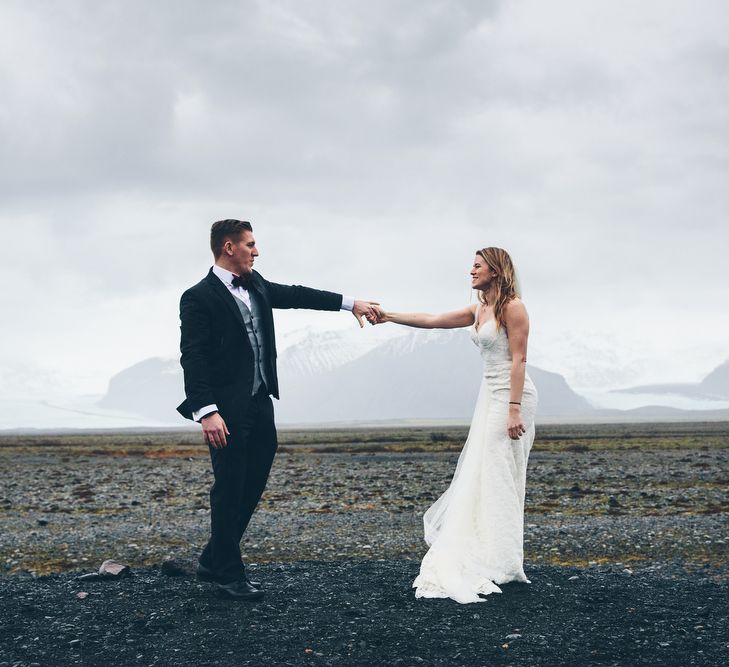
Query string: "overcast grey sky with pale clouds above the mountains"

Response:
xmin=0 ymin=0 xmax=729 ymax=397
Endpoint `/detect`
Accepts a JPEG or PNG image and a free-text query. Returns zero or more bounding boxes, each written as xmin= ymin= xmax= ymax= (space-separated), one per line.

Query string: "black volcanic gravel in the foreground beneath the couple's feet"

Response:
xmin=0 ymin=560 xmax=729 ymax=666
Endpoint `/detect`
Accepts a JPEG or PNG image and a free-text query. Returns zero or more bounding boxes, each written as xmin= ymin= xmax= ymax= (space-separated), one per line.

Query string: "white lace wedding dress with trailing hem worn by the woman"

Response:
xmin=413 ymin=311 xmax=537 ymax=603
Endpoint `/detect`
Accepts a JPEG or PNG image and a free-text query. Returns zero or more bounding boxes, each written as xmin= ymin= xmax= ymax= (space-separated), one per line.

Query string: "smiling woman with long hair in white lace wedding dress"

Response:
xmin=370 ymin=247 xmax=537 ymax=603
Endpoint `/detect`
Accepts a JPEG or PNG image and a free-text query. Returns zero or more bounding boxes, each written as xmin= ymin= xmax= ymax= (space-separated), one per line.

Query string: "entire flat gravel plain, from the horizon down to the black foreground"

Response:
xmin=0 ymin=424 xmax=729 ymax=667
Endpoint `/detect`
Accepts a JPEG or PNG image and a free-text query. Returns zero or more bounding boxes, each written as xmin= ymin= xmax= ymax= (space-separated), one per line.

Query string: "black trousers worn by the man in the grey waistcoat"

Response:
xmin=200 ymin=392 xmax=278 ymax=582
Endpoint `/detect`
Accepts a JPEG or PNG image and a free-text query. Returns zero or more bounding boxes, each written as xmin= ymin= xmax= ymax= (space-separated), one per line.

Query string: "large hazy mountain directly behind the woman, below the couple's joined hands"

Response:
xmin=276 ymin=329 xmax=591 ymax=423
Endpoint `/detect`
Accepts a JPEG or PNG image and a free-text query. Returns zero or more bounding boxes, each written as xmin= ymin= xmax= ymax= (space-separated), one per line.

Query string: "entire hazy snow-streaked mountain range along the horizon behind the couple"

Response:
xmin=7 ymin=327 xmax=729 ymax=428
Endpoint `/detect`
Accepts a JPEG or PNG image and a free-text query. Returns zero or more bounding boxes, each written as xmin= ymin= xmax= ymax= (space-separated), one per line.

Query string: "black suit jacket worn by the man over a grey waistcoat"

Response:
xmin=177 ymin=269 xmax=342 ymax=421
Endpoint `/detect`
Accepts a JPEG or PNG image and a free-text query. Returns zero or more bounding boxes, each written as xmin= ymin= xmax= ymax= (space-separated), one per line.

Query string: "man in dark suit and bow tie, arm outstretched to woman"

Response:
xmin=177 ymin=220 xmax=375 ymax=599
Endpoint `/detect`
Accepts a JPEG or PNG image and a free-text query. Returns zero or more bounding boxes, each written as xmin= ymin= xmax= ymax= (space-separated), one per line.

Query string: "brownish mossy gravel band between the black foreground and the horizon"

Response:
xmin=0 ymin=449 xmax=729 ymax=574
